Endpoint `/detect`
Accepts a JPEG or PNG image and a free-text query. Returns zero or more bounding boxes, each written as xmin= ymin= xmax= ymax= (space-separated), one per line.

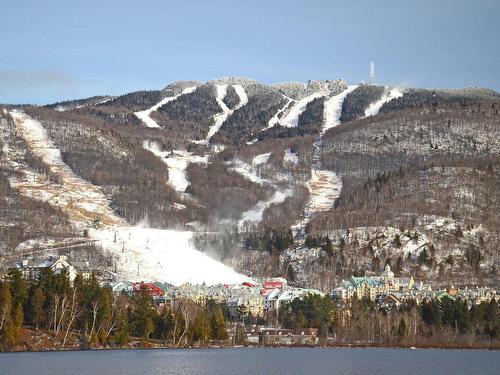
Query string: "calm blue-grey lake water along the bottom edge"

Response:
xmin=0 ymin=348 xmax=500 ymax=375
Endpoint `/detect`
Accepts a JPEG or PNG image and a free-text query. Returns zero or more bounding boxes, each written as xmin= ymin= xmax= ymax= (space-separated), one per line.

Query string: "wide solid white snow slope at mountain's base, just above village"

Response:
xmin=89 ymin=226 xmax=249 ymax=285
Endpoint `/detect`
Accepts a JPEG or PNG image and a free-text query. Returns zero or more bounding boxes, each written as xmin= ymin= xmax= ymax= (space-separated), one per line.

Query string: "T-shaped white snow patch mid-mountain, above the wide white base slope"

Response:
xmin=143 ymin=141 xmax=208 ymax=193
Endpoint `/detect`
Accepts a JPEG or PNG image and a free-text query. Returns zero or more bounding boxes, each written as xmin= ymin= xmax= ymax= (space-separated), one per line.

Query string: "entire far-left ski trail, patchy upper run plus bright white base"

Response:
xmin=0 ymin=111 xmax=249 ymax=285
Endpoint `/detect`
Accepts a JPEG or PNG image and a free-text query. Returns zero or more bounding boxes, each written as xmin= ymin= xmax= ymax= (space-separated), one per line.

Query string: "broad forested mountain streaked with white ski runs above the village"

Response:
xmin=0 ymin=77 xmax=500 ymax=291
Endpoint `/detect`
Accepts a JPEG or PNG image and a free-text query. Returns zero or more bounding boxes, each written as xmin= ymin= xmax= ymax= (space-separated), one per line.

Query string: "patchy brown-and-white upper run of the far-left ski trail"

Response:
xmin=9 ymin=110 xmax=126 ymax=225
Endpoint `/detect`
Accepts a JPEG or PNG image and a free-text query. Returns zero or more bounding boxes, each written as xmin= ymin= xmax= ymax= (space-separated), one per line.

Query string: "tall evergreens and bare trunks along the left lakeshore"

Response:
xmin=0 ymin=268 xmax=228 ymax=350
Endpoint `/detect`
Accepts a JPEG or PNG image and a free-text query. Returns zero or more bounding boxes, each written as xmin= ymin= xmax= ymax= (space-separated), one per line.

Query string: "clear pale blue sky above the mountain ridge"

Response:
xmin=0 ymin=0 xmax=500 ymax=104
